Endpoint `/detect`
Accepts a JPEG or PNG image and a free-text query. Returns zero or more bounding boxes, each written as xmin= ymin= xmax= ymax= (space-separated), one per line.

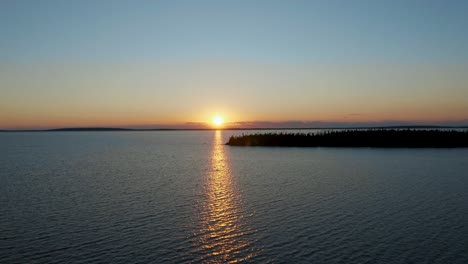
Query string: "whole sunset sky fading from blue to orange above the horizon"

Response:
xmin=0 ymin=0 xmax=468 ymax=129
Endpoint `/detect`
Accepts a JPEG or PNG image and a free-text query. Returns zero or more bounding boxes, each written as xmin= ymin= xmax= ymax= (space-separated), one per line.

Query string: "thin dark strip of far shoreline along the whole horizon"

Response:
xmin=0 ymin=125 xmax=468 ymax=133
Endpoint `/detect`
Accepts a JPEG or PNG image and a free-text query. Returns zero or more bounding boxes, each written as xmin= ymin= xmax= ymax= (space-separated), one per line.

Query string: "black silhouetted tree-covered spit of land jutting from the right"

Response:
xmin=226 ymin=129 xmax=468 ymax=148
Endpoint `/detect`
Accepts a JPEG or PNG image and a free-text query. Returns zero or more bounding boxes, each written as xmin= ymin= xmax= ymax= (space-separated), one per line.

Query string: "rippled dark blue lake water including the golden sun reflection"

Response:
xmin=0 ymin=131 xmax=468 ymax=263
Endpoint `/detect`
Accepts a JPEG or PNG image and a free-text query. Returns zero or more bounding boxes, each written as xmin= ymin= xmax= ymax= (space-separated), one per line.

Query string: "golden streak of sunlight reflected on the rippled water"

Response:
xmin=197 ymin=131 xmax=255 ymax=263
